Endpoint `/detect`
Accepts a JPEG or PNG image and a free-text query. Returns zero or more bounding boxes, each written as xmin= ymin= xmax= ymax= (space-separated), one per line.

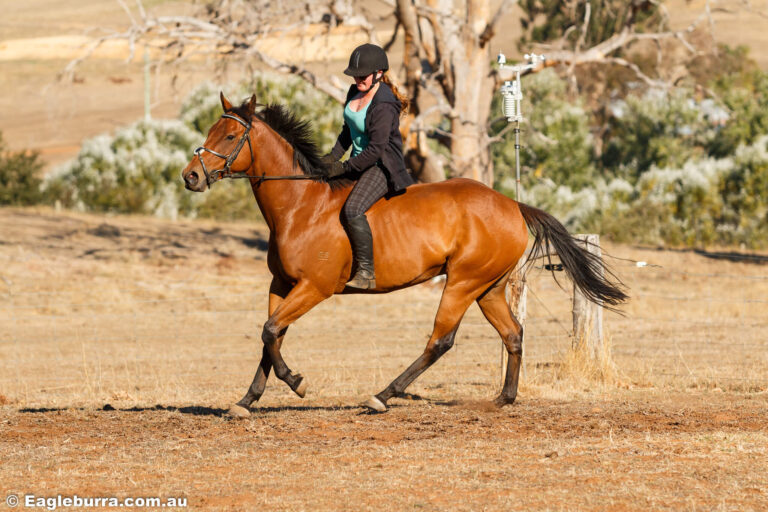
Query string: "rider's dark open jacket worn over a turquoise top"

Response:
xmin=331 ymin=82 xmax=414 ymax=192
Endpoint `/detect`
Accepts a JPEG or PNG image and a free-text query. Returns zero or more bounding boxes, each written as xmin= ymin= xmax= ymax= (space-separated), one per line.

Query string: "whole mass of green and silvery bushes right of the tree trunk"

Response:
xmin=494 ymin=68 xmax=768 ymax=247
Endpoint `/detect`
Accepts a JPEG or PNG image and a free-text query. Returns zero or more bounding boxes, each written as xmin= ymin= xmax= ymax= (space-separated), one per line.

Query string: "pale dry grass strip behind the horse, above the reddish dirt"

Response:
xmin=0 ymin=205 xmax=768 ymax=406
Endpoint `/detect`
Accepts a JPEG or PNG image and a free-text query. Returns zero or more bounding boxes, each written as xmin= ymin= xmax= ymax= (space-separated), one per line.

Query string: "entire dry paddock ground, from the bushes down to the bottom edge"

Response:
xmin=0 ymin=209 xmax=768 ymax=510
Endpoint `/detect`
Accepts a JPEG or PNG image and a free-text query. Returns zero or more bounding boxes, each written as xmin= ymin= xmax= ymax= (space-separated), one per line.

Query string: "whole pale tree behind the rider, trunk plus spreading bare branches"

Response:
xmin=65 ymin=0 xmax=728 ymax=188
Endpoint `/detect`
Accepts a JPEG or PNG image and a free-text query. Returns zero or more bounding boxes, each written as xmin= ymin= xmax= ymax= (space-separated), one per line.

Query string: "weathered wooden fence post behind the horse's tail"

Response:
xmin=573 ymin=235 xmax=604 ymax=360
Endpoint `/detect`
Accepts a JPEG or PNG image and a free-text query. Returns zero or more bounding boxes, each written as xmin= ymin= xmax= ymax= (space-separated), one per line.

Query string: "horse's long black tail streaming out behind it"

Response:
xmin=517 ymin=203 xmax=629 ymax=310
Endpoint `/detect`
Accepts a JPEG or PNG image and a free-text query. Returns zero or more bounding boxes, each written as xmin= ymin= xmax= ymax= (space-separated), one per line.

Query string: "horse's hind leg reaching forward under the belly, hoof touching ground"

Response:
xmin=363 ymin=279 xmax=479 ymax=412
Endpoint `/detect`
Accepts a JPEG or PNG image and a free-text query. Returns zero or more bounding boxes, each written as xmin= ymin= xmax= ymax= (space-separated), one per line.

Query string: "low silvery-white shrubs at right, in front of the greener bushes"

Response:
xmin=527 ymin=135 xmax=768 ymax=247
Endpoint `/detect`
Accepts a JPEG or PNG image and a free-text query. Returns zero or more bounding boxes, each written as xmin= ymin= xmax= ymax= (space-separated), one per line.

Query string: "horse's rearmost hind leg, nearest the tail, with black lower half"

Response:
xmin=477 ymin=278 xmax=523 ymax=407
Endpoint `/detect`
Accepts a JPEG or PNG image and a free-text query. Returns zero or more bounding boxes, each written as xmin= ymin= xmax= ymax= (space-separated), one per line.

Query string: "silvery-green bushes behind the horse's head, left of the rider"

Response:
xmin=44 ymin=74 xmax=341 ymax=219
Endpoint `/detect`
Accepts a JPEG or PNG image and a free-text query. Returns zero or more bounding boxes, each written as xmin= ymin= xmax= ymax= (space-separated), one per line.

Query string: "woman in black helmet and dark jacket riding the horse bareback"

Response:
xmin=325 ymin=44 xmax=414 ymax=289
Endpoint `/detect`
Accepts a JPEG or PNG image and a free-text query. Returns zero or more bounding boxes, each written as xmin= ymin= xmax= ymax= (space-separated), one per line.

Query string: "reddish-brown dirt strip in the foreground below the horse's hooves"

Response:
xmin=0 ymin=393 xmax=768 ymax=511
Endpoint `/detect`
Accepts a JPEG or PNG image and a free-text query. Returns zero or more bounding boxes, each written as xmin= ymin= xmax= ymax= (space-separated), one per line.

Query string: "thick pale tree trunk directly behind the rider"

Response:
xmin=396 ymin=0 xmax=494 ymax=186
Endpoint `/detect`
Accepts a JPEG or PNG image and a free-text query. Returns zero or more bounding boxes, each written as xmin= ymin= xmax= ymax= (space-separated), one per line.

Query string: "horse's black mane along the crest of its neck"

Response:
xmin=232 ymin=100 xmax=350 ymax=188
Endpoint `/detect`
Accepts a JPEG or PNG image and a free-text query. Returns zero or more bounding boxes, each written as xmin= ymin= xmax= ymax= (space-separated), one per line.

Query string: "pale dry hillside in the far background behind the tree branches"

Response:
xmin=0 ymin=0 xmax=768 ymax=170
